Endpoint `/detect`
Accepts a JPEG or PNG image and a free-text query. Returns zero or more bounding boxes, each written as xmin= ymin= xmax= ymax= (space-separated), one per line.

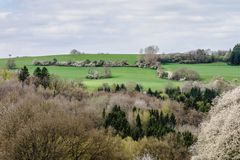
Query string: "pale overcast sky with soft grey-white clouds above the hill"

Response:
xmin=0 ymin=0 xmax=240 ymax=57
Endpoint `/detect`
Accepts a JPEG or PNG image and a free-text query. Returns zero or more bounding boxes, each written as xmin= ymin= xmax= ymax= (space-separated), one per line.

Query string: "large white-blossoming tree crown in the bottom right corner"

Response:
xmin=192 ymin=87 xmax=240 ymax=160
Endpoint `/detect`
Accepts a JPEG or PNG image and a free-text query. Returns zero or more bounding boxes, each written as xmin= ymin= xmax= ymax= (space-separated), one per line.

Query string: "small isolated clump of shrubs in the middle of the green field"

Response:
xmin=86 ymin=67 xmax=112 ymax=79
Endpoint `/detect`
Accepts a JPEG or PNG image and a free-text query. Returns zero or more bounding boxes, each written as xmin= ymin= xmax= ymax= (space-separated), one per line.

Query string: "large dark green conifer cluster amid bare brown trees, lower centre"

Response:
xmin=103 ymin=105 xmax=176 ymax=140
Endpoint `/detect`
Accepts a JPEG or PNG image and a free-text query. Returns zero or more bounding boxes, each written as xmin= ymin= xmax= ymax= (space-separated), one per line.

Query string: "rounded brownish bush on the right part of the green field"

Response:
xmin=172 ymin=68 xmax=200 ymax=81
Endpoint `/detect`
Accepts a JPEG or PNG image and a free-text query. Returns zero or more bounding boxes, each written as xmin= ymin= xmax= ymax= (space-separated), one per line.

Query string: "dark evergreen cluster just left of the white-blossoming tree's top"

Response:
xmin=165 ymin=87 xmax=219 ymax=112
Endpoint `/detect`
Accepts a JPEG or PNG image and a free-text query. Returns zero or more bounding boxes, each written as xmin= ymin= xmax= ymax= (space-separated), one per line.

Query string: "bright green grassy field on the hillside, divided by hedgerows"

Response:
xmin=0 ymin=54 xmax=240 ymax=90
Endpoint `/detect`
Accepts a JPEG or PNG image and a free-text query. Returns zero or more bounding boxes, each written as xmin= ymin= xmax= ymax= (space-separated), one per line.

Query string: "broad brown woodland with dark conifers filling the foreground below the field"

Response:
xmin=3 ymin=72 xmax=227 ymax=160
